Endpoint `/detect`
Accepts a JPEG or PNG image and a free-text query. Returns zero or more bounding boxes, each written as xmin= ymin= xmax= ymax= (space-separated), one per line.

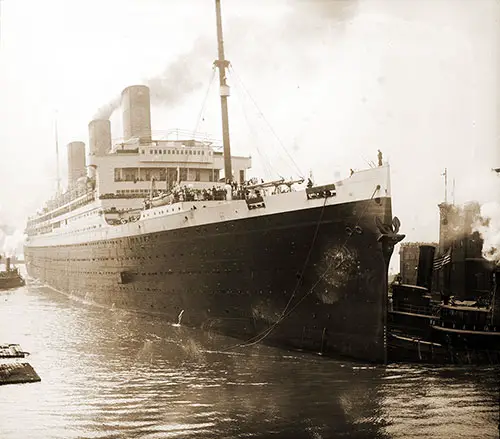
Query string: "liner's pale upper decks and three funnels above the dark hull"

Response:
xmin=26 ymin=86 xmax=391 ymax=251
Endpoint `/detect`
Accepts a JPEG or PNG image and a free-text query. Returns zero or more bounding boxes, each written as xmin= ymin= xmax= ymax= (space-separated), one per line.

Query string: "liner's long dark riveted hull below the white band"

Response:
xmin=25 ymin=198 xmax=392 ymax=362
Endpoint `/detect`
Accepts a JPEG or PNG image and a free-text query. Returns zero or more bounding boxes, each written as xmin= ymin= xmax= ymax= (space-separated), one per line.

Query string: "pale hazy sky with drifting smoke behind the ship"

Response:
xmin=0 ymin=0 xmax=500 ymax=266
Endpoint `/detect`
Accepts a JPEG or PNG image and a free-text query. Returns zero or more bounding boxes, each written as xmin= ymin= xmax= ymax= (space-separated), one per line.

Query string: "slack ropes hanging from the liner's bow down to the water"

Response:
xmin=227 ymin=186 xmax=379 ymax=349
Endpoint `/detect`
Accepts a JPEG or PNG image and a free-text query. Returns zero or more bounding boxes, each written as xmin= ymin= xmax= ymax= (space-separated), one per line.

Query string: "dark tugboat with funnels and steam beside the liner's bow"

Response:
xmin=388 ymin=201 xmax=500 ymax=364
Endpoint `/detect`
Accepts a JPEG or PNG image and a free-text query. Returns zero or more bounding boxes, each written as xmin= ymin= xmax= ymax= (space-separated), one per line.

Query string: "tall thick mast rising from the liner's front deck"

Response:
xmin=214 ymin=0 xmax=233 ymax=183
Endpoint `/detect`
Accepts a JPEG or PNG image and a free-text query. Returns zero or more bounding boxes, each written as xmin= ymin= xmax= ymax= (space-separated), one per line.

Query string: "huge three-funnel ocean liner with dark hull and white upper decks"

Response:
xmin=24 ymin=0 xmax=403 ymax=362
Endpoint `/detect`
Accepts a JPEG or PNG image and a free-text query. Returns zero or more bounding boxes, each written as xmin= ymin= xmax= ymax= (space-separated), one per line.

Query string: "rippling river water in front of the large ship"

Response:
xmin=0 ymin=274 xmax=499 ymax=439
